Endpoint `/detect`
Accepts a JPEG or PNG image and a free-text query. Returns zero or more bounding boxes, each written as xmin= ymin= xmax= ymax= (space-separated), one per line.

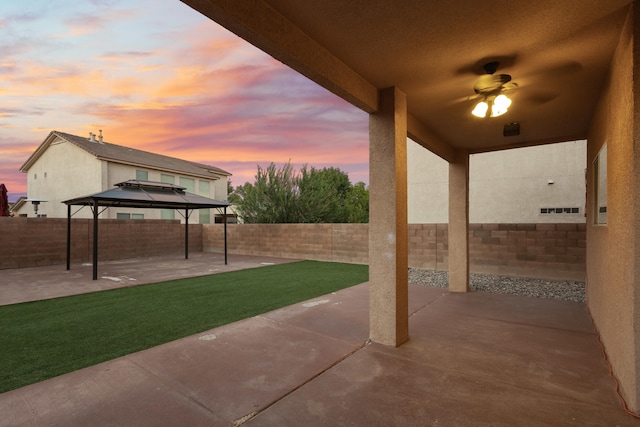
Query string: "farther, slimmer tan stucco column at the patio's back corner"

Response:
xmin=449 ymin=149 xmax=469 ymax=292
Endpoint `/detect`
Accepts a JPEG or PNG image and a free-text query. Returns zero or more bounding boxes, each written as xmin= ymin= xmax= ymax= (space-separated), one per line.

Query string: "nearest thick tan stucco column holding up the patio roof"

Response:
xmin=369 ymin=88 xmax=409 ymax=346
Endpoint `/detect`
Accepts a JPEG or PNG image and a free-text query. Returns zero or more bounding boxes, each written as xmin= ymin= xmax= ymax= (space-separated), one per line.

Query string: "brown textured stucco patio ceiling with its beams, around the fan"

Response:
xmin=182 ymin=0 xmax=631 ymax=158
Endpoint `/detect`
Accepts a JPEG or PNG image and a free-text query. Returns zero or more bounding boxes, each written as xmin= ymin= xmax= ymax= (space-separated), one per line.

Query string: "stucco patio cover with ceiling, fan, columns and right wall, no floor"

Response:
xmin=182 ymin=0 xmax=640 ymax=412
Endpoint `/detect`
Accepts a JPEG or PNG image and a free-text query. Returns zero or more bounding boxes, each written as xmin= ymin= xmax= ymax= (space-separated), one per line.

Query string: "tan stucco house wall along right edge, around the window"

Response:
xmin=587 ymin=7 xmax=640 ymax=411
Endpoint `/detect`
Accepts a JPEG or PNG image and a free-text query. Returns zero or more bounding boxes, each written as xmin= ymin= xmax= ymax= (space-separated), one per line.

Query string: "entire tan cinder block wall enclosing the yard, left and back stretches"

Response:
xmin=0 ymin=218 xmax=586 ymax=281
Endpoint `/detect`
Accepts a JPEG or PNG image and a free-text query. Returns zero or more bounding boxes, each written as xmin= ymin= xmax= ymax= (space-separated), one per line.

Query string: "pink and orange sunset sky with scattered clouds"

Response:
xmin=0 ymin=0 xmax=369 ymax=201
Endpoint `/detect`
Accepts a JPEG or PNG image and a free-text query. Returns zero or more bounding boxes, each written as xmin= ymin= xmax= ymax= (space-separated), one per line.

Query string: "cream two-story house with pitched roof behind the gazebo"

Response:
xmin=13 ymin=131 xmax=231 ymax=224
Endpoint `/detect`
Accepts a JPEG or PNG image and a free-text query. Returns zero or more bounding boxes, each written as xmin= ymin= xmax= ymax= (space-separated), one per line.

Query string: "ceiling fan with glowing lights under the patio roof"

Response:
xmin=469 ymin=61 xmax=518 ymax=117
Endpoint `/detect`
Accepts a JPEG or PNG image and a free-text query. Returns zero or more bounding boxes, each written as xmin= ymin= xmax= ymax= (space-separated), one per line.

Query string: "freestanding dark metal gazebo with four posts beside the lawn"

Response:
xmin=62 ymin=179 xmax=229 ymax=280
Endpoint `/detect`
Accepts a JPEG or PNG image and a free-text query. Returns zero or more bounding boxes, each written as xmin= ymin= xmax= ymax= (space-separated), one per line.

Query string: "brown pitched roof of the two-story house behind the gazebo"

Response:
xmin=20 ymin=130 xmax=231 ymax=179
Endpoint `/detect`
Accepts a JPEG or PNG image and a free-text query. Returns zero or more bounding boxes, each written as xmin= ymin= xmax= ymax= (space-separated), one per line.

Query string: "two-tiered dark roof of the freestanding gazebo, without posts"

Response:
xmin=62 ymin=179 xmax=230 ymax=209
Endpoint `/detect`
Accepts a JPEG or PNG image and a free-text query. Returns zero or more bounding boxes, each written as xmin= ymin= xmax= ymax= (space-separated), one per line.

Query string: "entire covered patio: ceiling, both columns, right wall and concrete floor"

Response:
xmin=0 ymin=0 xmax=640 ymax=426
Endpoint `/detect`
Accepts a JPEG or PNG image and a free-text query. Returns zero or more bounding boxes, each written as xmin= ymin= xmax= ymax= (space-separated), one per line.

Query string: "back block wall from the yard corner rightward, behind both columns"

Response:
xmin=203 ymin=224 xmax=586 ymax=281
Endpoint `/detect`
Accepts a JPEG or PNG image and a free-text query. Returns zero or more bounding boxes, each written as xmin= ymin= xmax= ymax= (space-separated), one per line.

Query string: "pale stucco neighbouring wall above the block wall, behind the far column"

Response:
xmin=407 ymin=140 xmax=587 ymax=224
